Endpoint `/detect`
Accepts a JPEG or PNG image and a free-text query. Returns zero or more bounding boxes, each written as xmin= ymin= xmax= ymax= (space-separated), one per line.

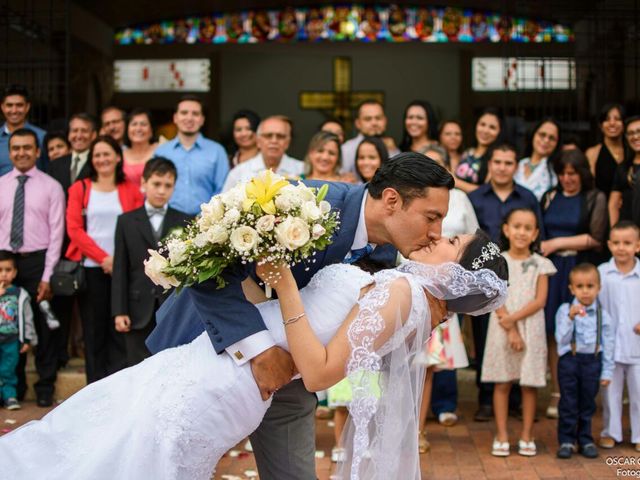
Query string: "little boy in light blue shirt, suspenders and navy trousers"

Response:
xmin=556 ymin=263 xmax=615 ymax=459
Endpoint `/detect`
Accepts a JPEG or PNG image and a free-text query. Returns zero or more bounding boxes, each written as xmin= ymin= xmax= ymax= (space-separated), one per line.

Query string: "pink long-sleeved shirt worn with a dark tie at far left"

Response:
xmin=0 ymin=167 xmax=65 ymax=282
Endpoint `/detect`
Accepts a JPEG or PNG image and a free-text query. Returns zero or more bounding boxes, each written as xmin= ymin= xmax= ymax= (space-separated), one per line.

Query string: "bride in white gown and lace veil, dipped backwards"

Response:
xmin=0 ymin=232 xmax=507 ymax=480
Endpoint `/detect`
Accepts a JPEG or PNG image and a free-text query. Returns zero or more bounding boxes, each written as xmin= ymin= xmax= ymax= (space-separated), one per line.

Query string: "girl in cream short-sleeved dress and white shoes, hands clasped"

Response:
xmin=481 ymin=208 xmax=556 ymax=457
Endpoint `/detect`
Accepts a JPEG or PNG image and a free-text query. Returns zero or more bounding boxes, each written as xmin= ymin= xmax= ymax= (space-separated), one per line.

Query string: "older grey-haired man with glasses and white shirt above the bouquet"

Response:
xmin=222 ymin=115 xmax=304 ymax=192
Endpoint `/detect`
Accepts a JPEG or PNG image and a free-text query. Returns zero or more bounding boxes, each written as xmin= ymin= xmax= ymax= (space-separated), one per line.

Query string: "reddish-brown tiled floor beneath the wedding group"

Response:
xmin=0 ymin=370 xmax=640 ymax=480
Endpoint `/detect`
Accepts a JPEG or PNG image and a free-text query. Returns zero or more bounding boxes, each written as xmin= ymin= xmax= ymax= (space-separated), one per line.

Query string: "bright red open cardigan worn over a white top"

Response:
xmin=65 ymin=178 xmax=144 ymax=263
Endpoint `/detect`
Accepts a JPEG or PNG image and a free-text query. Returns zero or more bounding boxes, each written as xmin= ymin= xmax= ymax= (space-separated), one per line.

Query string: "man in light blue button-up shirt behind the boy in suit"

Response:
xmin=155 ymin=95 xmax=229 ymax=215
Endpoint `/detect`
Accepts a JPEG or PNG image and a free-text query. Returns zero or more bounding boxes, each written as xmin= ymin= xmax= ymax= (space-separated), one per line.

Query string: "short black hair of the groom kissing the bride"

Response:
xmin=369 ymin=152 xmax=455 ymax=204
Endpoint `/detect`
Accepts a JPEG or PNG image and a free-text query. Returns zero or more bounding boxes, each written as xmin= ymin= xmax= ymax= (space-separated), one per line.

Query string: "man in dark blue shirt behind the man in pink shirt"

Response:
xmin=0 ymin=85 xmax=48 ymax=176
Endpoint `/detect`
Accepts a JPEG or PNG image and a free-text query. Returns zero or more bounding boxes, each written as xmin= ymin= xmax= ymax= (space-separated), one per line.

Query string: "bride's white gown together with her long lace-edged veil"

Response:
xmin=0 ymin=262 xmax=504 ymax=480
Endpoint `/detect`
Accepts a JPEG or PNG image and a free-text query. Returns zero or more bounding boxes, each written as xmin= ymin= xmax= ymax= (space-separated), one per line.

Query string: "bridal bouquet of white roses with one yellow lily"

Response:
xmin=145 ymin=170 xmax=339 ymax=289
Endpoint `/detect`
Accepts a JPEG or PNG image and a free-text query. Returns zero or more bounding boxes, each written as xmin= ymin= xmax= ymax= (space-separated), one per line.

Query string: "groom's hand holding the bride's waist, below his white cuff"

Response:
xmin=250 ymin=347 xmax=295 ymax=400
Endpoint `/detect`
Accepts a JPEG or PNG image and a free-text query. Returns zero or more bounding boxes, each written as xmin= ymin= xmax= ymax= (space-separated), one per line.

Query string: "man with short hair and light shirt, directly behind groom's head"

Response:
xmin=342 ymin=100 xmax=399 ymax=173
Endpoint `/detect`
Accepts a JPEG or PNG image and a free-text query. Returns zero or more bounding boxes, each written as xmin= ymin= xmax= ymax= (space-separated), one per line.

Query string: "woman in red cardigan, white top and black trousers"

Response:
xmin=66 ymin=136 xmax=144 ymax=383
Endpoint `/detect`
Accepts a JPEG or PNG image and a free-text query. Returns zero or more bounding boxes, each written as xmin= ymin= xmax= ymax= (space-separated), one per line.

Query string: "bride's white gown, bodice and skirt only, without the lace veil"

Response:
xmin=0 ymin=264 xmax=373 ymax=480
